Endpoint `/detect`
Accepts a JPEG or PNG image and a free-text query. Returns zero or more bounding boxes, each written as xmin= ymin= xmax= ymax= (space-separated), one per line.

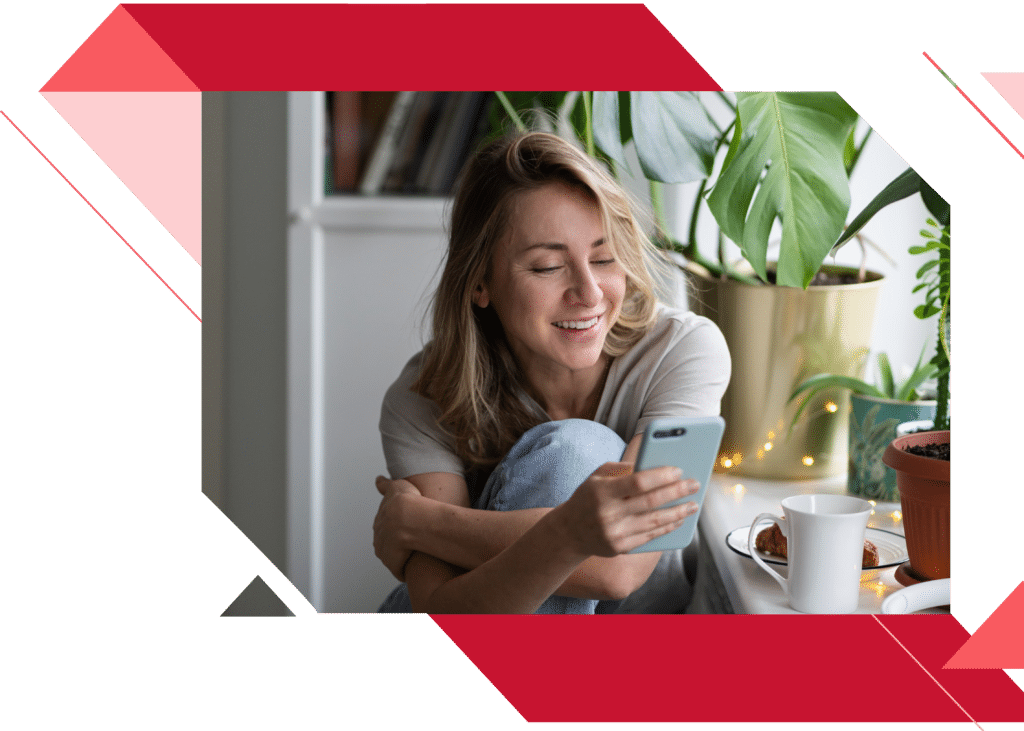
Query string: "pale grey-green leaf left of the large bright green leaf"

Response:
xmin=626 ymin=91 xmax=718 ymax=183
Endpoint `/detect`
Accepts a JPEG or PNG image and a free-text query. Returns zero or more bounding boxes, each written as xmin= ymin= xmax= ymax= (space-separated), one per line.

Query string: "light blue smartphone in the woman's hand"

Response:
xmin=631 ymin=417 xmax=725 ymax=553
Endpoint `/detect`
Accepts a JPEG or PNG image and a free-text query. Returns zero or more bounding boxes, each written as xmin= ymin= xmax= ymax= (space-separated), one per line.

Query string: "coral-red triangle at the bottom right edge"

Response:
xmin=943 ymin=582 xmax=1024 ymax=670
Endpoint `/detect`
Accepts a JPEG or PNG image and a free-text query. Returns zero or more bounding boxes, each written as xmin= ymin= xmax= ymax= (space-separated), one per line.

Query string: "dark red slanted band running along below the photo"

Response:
xmin=431 ymin=614 xmax=1024 ymax=724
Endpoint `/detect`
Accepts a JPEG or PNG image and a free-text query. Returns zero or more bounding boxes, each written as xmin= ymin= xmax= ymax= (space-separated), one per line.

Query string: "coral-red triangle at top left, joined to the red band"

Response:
xmin=40 ymin=5 xmax=199 ymax=91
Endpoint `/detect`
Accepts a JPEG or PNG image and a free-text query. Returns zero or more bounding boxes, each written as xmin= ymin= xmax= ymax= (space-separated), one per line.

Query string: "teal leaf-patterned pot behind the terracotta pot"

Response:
xmin=847 ymin=393 xmax=935 ymax=502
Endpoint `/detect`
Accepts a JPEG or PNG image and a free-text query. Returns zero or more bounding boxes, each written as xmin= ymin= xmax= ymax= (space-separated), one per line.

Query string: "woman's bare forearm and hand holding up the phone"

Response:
xmin=406 ymin=463 xmax=693 ymax=613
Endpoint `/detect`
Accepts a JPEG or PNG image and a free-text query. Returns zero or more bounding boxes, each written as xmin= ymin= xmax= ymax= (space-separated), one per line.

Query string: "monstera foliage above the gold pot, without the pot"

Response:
xmin=498 ymin=91 xmax=867 ymax=288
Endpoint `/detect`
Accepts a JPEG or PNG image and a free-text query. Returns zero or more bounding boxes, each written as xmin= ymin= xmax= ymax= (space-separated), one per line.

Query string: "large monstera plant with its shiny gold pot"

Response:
xmin=499 ymin=92 xmax=882 ymax=478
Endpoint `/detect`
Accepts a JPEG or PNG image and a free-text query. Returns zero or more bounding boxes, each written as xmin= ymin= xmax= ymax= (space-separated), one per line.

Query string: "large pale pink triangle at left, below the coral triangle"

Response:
xmin=41 ymin=91 xmax=203 ymax=265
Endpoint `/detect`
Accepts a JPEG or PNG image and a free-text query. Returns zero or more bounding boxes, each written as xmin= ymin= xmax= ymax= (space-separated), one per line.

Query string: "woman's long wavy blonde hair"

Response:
xmin=413 ymin=132 xmax=657 ymax=469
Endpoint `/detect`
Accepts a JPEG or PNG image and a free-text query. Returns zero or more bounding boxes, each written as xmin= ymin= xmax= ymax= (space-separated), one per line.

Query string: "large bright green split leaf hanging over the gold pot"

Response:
xmin=708 ymin=91 xmax=857 ymax=287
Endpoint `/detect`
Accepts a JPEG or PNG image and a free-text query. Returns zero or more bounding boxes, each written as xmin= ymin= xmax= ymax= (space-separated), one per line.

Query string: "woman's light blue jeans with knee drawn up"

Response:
xmin=377 ymin=419 xmax=626 ymax=614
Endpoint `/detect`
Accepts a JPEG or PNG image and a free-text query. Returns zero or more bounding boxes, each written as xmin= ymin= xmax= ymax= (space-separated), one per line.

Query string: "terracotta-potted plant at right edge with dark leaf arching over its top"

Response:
xmin=837 ymin=169 xmax=952 ymax=584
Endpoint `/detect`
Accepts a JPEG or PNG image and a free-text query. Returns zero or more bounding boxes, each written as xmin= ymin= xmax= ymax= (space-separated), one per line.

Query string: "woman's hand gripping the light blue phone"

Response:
xmin=555 ymin=462 xmax=699 ymax=557
